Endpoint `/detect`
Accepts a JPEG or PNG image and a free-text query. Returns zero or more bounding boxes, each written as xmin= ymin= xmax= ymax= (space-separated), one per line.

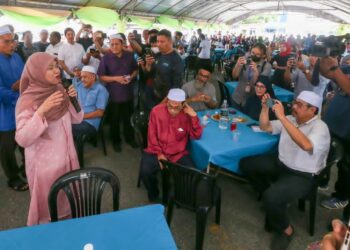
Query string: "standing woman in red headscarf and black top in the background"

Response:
xmin=271 ymin=42 xmax=292 ymax=89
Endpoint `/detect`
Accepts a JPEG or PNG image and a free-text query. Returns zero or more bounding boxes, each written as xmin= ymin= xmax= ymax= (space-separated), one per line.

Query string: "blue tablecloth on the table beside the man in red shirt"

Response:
xmin=191 ymin=111 xmax=278 ymax=173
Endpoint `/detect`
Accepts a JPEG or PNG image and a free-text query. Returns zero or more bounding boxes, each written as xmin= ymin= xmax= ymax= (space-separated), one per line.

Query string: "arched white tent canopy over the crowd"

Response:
xmin=0 ymin=0 xmax=350 ymax=26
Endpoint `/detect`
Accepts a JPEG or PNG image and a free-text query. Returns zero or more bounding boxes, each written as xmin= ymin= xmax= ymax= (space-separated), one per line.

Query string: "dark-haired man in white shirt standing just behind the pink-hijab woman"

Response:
xmin=57 ymin=28 xmax=85 ymax=79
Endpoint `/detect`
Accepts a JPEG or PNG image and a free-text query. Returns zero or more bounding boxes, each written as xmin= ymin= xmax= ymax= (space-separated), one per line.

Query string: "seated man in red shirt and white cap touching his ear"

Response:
xmin=141 ymin=89 xmax=203 ymax=202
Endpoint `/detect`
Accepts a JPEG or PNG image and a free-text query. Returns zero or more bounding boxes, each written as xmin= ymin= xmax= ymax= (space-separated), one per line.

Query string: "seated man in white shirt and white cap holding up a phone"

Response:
xmin=240 ymin=91 xmax=330 ymax=249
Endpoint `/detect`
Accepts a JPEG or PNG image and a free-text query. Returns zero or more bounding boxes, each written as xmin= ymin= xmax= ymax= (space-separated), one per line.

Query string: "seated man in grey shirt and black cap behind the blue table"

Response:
xmin=182 ymin=65 xmax=218 ymax=111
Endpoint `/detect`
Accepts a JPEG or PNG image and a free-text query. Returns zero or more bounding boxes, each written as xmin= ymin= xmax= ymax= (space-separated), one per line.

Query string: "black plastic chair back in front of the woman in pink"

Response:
xmin=49 ymin=168 xmax=120 ymax=221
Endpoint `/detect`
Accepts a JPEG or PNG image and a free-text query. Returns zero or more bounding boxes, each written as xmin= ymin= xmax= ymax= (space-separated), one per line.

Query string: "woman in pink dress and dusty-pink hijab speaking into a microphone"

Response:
xmin=16 ymin=52 xmax=84 ymax=226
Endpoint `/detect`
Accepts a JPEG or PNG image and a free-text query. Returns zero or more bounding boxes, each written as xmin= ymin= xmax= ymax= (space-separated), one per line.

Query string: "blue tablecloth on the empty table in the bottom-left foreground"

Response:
xmin=0 ymin=205 xmax=177 ymax=250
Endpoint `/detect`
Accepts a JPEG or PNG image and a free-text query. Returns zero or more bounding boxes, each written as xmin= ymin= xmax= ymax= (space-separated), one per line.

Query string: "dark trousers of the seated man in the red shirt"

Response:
xmin=141 ymin=152 xmax=194 ymax=200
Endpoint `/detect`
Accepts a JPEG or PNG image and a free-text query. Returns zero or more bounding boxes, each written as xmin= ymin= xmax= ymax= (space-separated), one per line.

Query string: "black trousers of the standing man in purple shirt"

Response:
xmin=110 ymin=100 xmax=134 ymax=144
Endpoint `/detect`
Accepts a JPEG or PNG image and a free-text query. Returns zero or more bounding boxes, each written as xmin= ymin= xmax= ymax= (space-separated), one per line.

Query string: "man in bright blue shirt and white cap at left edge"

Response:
xmin=0 ymin=26 xmax=28 ymax=191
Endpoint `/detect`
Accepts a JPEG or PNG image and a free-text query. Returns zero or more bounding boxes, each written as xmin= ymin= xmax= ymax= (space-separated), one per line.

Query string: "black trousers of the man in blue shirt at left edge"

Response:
xmin=0 ymin=130 xmax=24 ymax=182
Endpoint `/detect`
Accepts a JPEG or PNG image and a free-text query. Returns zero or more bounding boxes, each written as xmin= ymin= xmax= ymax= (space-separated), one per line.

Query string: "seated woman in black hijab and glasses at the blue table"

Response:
xmin=243 ymin=76 xmax=276 ymax=121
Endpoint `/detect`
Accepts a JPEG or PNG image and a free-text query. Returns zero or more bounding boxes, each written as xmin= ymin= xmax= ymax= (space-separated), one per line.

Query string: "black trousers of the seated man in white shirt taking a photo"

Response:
xmin=240 ymin=154 xmax=315 ymax=233
